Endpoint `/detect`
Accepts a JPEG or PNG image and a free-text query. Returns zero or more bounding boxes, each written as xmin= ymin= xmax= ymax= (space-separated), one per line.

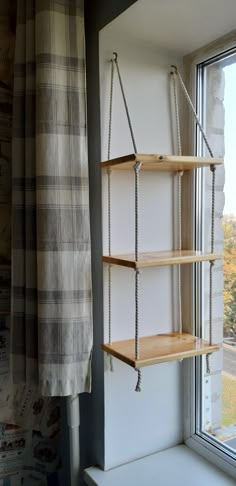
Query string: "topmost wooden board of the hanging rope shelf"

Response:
xmin=101 ymin=154 xmax=224 ymax=172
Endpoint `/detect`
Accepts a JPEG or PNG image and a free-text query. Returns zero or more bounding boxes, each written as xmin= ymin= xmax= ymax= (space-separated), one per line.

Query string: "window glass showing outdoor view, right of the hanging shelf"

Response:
xmin=201 ymin=55 xmax=236 ymax=451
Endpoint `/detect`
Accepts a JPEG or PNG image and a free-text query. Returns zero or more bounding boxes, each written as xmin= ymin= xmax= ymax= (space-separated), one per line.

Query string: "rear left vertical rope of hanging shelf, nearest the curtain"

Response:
xmin=107 ymin=55 xmax=114 ymax=371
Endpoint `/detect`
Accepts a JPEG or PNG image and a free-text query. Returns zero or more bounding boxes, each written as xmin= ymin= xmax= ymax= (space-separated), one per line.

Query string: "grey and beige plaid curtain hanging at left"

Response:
xmin=11 ymin=0 xmax=92 ymax=396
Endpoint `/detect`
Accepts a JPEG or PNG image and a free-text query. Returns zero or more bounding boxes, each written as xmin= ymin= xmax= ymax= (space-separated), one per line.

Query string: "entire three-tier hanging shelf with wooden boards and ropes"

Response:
xmin=101 ymin=53 xmax=223 ymax=391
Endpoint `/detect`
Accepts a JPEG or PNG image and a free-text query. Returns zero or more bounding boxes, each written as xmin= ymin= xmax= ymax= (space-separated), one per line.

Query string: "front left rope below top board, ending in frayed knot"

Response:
xmin=134 ymin=162 xmax=142 ymax=392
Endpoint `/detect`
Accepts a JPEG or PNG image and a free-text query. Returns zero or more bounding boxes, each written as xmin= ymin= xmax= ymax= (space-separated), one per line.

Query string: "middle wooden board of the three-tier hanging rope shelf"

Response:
xmin=102 ymin=250 xmax=222 ymax=268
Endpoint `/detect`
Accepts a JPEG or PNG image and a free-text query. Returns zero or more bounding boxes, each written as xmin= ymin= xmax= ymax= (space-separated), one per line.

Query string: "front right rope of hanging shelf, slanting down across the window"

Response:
xmin=171 ymin=65 xmax=216 ymax=374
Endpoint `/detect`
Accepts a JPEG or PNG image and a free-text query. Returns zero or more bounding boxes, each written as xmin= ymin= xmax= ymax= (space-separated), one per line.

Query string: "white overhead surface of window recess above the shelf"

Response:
xmin=103 ymin=0 xmax=236 ymax=55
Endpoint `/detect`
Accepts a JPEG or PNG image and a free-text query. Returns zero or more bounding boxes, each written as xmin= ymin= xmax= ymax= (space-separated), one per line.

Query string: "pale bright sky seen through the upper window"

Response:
xmin=224 ymin=63 xmax=236 ymax=215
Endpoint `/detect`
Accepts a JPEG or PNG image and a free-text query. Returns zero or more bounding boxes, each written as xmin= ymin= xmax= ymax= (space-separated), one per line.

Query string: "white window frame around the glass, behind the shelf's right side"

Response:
xmin=184 ymin=31 xmax=236 ymax=478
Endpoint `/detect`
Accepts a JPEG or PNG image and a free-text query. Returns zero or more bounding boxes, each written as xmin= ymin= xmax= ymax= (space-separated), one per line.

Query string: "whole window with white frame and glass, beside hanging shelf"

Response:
xmin=184 ymin=43 xmax=236 ymax=475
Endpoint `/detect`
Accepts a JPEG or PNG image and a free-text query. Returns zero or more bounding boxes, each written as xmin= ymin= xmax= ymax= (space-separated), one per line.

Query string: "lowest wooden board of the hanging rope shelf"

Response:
xmin=102 ymin=332 xmax=220 ymax=368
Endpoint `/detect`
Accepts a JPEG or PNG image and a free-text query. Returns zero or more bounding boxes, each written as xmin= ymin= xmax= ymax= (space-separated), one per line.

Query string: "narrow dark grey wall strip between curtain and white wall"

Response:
xmin=74 ymin=0 xmax=135 ymax=482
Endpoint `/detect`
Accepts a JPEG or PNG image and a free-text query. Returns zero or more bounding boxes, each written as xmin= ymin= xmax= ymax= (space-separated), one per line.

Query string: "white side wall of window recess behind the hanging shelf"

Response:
xmin=100 ymin=31 xmax=183 ymax=469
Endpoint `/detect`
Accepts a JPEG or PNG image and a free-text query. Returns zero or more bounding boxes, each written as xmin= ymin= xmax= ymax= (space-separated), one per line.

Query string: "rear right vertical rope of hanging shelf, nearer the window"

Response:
xmin=171 ymin=71 xmax=184 ymax=334
